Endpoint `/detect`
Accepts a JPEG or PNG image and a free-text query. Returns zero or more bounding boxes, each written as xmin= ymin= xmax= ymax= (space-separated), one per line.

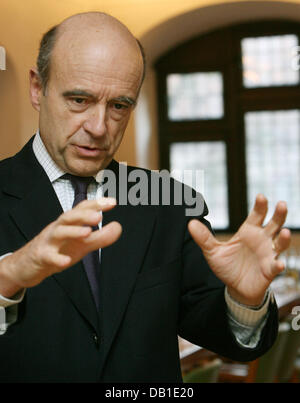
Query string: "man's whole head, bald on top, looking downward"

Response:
xmin=30 ymin=13 xmax=144 ymax=176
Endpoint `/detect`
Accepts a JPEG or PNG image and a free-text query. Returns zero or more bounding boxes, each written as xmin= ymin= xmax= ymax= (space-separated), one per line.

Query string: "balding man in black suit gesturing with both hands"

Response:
xmin=0 ymin=13 xmax=290 ymax=382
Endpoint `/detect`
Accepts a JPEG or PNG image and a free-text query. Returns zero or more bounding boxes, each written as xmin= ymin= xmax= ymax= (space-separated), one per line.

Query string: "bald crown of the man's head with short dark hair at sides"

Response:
xmin=37 ymin=12 xmax=145 ymax=92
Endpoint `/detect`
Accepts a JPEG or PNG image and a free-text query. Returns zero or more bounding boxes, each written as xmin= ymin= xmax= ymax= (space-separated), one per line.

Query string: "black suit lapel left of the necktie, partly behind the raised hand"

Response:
xmin=3 ymin=140 xmax=98 ymax=331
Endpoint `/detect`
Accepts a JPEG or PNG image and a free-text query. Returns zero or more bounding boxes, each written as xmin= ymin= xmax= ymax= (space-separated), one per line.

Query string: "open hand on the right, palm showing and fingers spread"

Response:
xmin=188 ymin=194 xmax=291 ymax=306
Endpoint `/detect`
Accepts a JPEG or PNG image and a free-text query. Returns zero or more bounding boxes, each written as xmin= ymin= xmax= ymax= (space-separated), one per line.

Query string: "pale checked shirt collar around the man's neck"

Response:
xmin=32 ymin=130 xmax=103 ymax=183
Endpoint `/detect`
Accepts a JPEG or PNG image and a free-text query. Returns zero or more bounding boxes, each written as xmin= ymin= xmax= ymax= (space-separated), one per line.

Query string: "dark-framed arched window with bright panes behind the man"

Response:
xmin=155 ymin=21 xmax=300 ymax=232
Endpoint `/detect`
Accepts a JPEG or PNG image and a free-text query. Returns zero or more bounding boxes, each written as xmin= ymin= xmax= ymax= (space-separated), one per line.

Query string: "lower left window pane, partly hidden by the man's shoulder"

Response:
xmin=170 ymin=141 xmax=229 ymax=229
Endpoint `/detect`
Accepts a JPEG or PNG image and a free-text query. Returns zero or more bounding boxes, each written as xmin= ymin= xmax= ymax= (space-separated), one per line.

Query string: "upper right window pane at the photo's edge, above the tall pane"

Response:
xmin=241 ymin=35 xmax=299 ymax=88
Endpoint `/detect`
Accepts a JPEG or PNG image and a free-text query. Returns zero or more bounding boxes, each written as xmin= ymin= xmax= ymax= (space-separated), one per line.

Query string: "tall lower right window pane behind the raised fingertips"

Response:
xmin=245 ymin=110 xmax=300 ymax=228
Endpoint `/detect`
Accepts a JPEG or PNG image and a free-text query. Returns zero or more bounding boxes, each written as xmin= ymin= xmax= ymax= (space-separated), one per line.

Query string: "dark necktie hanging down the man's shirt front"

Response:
xmin=63 ymin=174 xmax=100 ymax=310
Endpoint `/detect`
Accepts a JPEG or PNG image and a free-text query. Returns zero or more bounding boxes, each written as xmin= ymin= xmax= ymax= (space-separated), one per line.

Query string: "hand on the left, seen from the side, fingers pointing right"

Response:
xmin=0 ymin=198 xmax=122 ymax=298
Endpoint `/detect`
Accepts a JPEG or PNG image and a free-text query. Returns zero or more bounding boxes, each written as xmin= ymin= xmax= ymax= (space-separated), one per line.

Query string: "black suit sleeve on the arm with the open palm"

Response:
xmin=179 ymin=213 xmax=278 ymax=361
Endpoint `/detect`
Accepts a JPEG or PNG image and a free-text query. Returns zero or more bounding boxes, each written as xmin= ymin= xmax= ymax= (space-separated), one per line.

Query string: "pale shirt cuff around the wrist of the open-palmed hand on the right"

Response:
xmin=225 ymin=287 xmax=274 ymax=327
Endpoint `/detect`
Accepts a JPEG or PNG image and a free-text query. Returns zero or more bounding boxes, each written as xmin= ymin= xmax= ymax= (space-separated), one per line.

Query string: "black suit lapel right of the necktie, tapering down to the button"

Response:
xmin=100 ymin=165 xmax=156 ymax=365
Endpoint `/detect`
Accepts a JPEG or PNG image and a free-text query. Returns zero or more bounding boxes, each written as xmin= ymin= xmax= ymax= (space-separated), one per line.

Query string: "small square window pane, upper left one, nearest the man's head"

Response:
xmin=167 ymin=72 xmax=224 ymax=121
